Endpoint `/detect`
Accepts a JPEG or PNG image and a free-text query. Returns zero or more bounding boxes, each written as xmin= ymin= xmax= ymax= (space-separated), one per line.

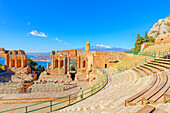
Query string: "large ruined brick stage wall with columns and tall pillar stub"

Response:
xmin=46 ymin=41 xmax=126 ymax=77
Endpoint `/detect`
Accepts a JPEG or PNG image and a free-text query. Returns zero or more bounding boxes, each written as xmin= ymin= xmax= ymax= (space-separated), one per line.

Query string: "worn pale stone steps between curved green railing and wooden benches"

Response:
xmin=55 ymin=70 xmax=152 ymax=112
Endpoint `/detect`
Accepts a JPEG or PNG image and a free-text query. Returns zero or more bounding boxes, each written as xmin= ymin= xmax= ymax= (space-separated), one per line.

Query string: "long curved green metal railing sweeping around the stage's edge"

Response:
xmin=0 ymin=69 xmax=108 ymax=113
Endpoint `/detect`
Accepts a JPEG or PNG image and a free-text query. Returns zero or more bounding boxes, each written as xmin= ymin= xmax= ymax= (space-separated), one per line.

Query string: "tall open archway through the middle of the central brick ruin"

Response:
xmin=69 ymin=58 xmax=77 ymax=81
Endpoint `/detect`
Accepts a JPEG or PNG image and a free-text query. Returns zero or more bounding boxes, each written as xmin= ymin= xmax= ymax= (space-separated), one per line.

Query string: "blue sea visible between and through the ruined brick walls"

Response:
xmin=0 ymin=55 xmax=50 ymax=68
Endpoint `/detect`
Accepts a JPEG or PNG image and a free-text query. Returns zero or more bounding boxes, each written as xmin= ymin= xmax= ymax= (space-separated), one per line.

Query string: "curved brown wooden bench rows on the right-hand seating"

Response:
xmin=125 ymin=57 xmax=170 ymax=106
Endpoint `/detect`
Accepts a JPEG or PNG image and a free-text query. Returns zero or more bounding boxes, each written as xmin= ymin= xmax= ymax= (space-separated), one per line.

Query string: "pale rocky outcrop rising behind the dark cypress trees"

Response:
xmin=148 ymin=16 xmax=170 ymax=38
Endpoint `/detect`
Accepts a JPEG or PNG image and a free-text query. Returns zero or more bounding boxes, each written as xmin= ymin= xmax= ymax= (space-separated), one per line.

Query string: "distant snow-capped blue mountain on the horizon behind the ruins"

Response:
xmin=77 ymin=44 xmax=128 ymax=52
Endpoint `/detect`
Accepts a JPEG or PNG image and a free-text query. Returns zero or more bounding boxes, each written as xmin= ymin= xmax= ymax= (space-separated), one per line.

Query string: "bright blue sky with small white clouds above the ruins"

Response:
xmin=0 ymin=0 xmax=170 ymax=52
